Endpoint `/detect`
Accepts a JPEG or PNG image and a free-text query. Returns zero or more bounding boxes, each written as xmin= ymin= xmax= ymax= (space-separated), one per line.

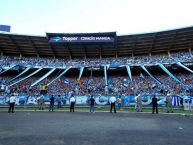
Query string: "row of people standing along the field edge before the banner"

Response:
xmin=8 ymin=90 xmax=173 ymax=114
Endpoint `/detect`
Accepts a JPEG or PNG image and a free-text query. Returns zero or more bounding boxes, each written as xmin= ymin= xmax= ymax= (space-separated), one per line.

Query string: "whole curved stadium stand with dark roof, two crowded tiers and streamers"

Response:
xmin=0 ymin=27 xmax=193 ymax=106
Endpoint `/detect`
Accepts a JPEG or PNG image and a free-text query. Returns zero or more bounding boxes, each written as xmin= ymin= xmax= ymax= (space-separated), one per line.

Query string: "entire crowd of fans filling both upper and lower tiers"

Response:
xmin=0 ymin=52 xmax=193 ymax=96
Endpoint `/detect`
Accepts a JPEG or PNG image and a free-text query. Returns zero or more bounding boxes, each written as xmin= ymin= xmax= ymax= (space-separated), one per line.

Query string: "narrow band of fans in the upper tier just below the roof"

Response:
xmin=0 ymin=52 xmax=193 ymax=68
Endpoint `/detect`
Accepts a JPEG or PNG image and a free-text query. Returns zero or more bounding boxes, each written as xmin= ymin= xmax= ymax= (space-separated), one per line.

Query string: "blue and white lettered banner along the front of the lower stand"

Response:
xmin=0 ymin=94 xmax=189 ymax=107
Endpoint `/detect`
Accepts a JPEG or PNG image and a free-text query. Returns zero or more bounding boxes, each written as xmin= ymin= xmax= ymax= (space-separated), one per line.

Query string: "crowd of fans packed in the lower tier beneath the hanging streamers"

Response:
xmin=0 ymin=73 xmax=193 ymax=96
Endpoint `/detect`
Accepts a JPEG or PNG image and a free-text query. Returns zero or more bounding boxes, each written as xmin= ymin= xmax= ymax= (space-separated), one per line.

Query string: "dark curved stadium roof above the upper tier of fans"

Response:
xmin=0 ymin=27 xmax=193 ymax=58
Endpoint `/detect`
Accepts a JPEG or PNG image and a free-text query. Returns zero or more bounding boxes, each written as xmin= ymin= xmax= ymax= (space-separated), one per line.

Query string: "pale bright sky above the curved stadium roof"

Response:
xmin=0 ymin=0 xmax=193 ymax=35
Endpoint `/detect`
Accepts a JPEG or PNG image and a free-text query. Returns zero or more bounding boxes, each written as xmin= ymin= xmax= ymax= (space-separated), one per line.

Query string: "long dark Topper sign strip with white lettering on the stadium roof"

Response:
xmin=49 ymin=36 xmax=115 ymax=43
